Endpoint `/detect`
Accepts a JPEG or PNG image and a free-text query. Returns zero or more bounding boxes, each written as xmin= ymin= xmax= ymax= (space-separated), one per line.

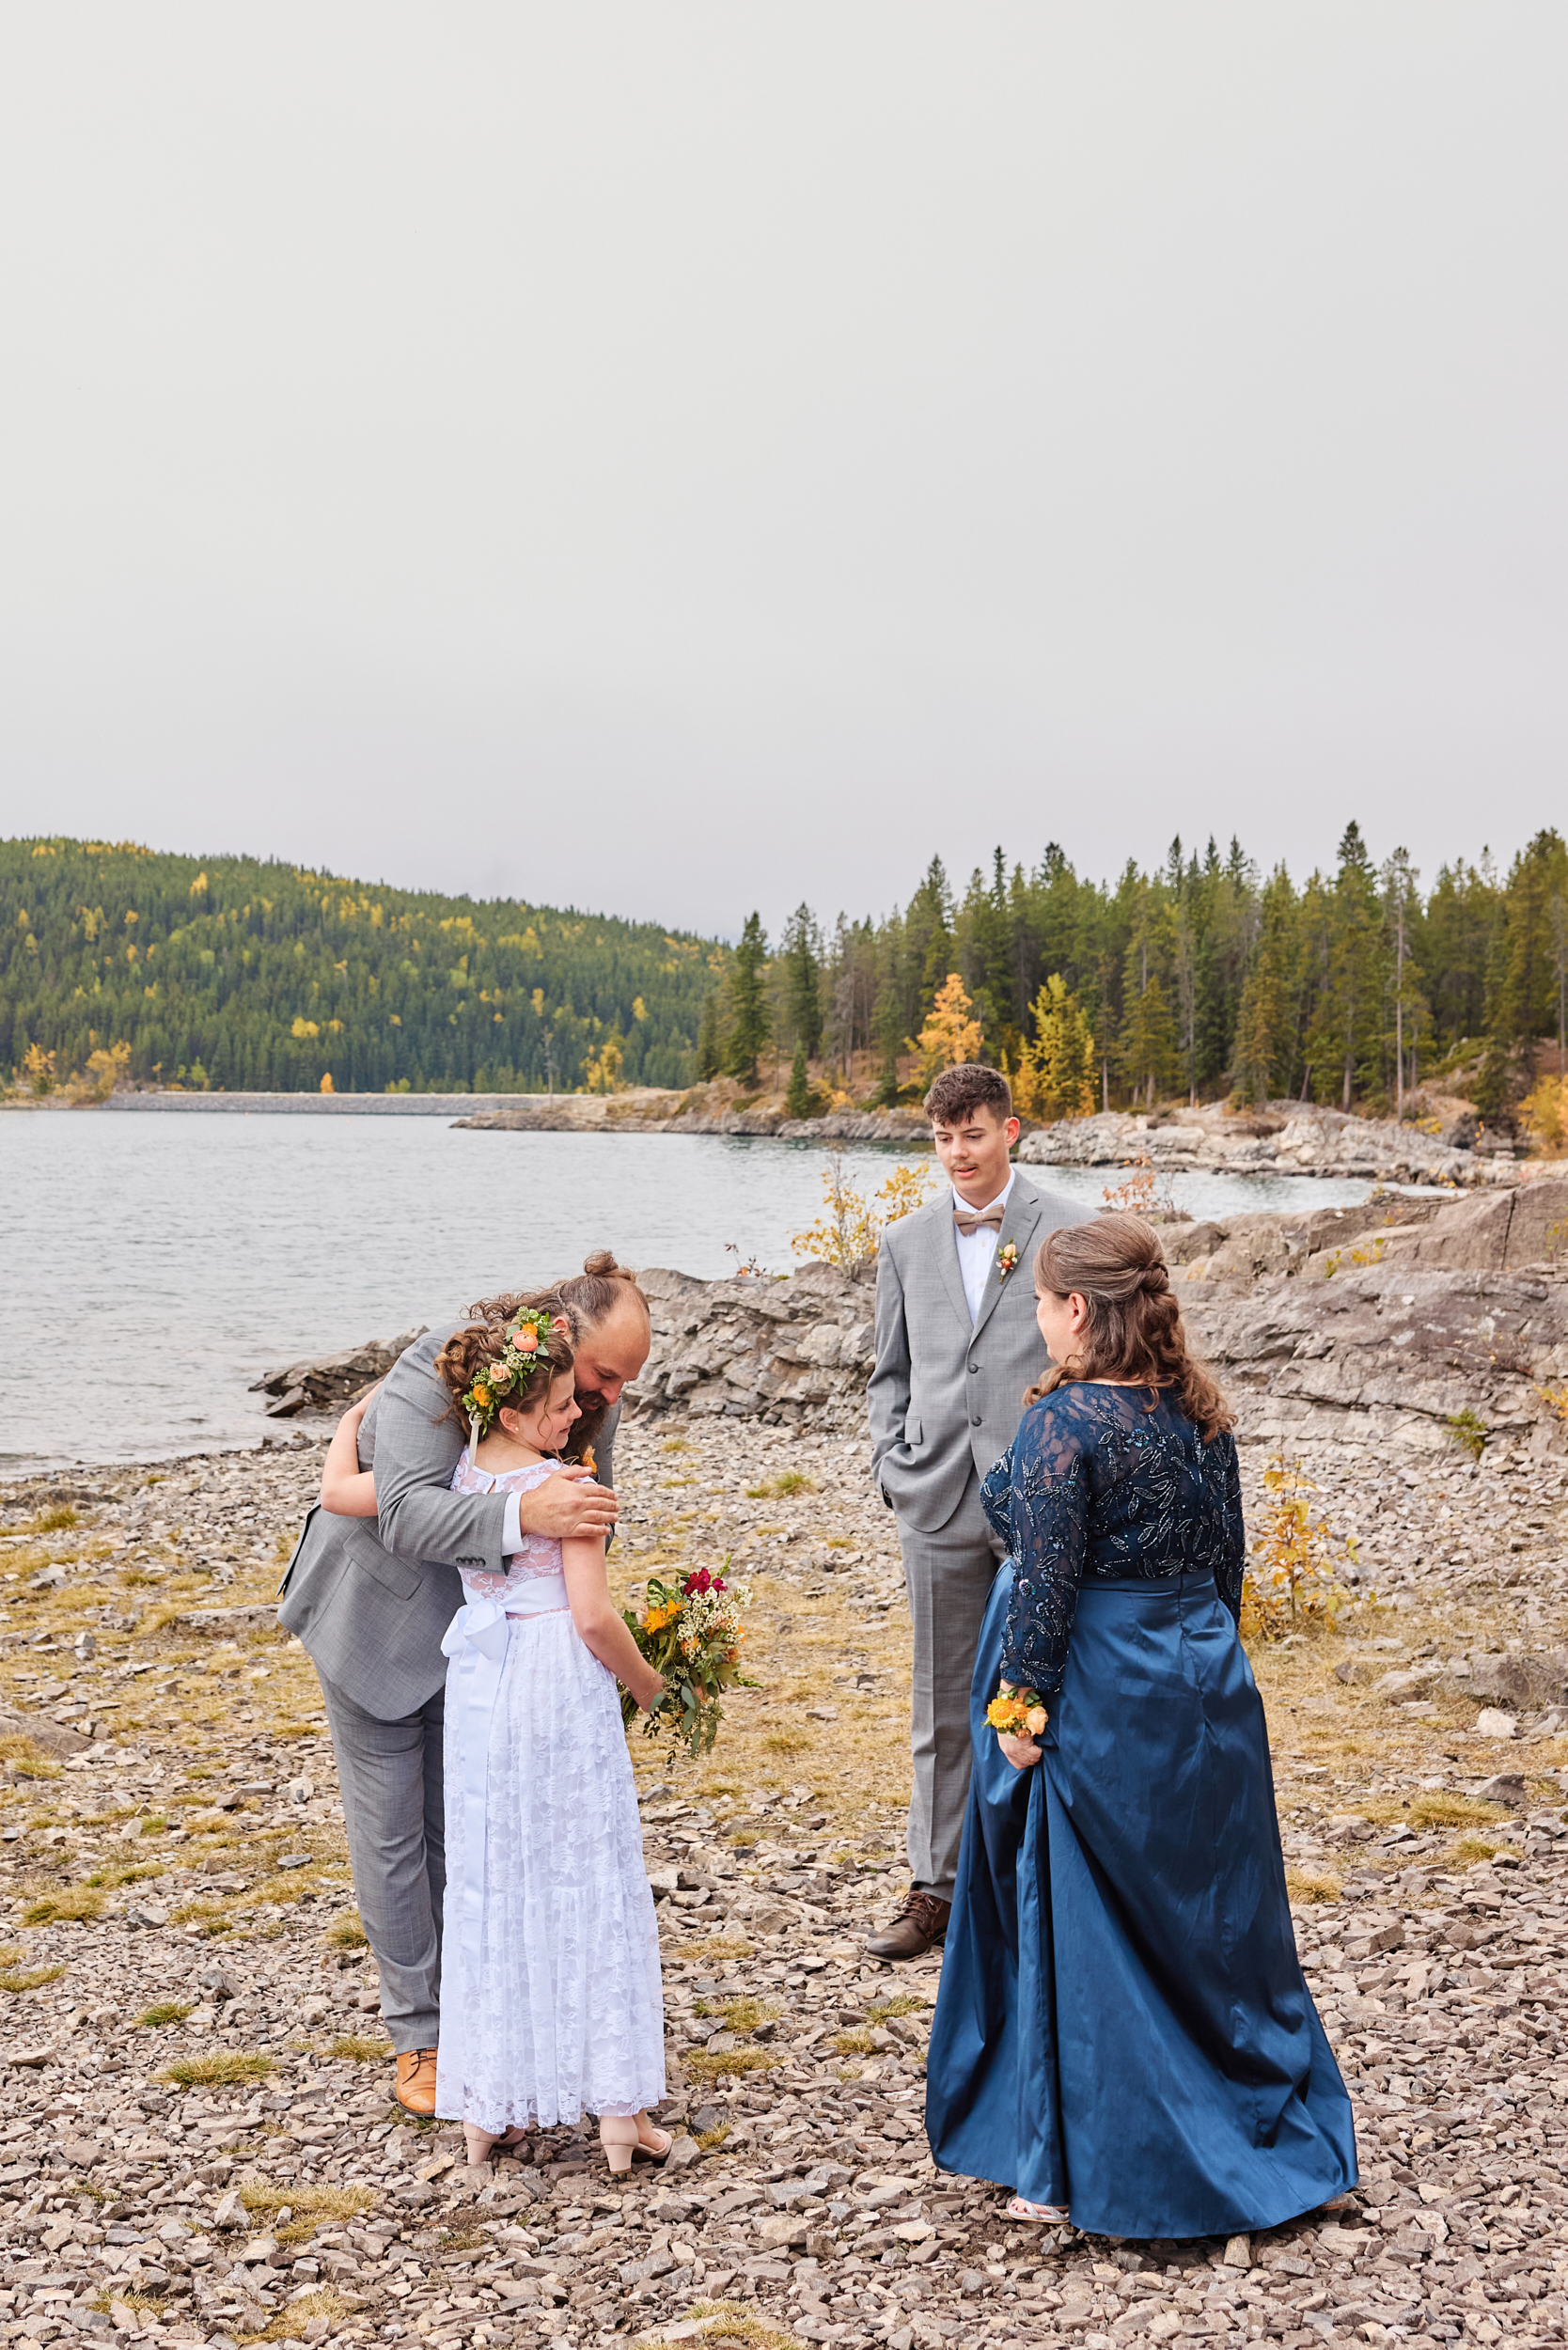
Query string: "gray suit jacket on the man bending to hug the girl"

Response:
xmin=277 ymin=1324 xmax=620 ymax=1723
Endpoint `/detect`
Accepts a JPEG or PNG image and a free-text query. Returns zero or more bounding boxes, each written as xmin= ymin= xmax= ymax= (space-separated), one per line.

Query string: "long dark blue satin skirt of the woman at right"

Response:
xmin=926 ymin=1560 xmax=1356 ymax=2237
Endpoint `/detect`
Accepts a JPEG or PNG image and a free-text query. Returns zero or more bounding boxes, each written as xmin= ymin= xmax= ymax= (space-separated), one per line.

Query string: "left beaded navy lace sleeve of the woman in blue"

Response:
xmin=1001 ymin=1399 xmax=1089 ymax=1697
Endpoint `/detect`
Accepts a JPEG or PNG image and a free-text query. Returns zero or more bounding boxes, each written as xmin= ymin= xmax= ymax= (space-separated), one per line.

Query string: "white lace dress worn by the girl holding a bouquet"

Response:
xmin=435 ymin=1450 xmax=666 ymax=2137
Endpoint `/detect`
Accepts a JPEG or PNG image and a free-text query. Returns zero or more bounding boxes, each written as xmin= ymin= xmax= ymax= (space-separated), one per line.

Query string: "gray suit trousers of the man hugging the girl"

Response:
xmin=318 ymin=1667 xmax=447 ymax=2057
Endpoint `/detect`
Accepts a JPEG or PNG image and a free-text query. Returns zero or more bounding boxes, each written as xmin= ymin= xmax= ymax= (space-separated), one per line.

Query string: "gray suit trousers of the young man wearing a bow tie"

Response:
xmin=898 ymin=1469 xmax=1001 ymax=1902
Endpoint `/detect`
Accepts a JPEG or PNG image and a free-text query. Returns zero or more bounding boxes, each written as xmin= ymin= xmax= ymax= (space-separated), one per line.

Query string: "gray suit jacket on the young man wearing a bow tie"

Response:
xmin=865 ymin=1175 xmax=1093 ymax=1535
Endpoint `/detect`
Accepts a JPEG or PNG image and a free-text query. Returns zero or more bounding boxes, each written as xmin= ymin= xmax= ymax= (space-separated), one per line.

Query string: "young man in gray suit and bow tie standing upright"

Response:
xmin=865 ymin=1062 xmax=1089 ymax=1958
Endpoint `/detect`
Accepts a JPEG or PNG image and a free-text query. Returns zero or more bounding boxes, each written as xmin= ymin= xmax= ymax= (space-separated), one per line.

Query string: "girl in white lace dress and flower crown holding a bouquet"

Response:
xmin=321 ymin=1309 xmax=670 ymax=2171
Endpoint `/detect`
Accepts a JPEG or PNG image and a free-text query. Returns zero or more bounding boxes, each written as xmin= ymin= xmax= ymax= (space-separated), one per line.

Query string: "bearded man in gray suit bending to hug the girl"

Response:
xmin=277 ymin=1255 xmax=649 ymax=2115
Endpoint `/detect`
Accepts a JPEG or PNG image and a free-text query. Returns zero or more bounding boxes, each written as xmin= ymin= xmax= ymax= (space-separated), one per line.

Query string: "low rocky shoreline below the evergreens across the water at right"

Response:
xmin=1018 ymin=1103 xmax=1521 ymax=1187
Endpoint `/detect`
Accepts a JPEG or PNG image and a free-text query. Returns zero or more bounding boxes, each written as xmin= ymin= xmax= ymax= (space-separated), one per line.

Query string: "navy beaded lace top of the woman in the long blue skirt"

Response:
xmin=980 ymin=1382 xmax=1246 ymax=1697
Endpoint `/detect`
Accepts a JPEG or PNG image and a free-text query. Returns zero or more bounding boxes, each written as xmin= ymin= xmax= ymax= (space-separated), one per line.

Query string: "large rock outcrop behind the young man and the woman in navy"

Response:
xmin=628 ymin=1180 xmax=1568 ymax=1450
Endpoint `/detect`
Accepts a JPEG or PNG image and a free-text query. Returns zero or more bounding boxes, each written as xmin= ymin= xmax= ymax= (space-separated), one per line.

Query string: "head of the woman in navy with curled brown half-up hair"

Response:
xmin=1023 ymin=1211 xmax=1236 ymax=1446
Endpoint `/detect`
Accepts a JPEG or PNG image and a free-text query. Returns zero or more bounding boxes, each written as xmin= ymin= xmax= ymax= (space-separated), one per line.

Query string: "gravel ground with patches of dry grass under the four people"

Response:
xmin=0 ymin=1419 xmax=1568 ymax=2350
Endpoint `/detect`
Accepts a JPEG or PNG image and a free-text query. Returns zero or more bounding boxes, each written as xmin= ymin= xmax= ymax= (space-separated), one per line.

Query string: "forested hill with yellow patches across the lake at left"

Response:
xmin=0 ymin=839 xmax=727 ymax=1093
